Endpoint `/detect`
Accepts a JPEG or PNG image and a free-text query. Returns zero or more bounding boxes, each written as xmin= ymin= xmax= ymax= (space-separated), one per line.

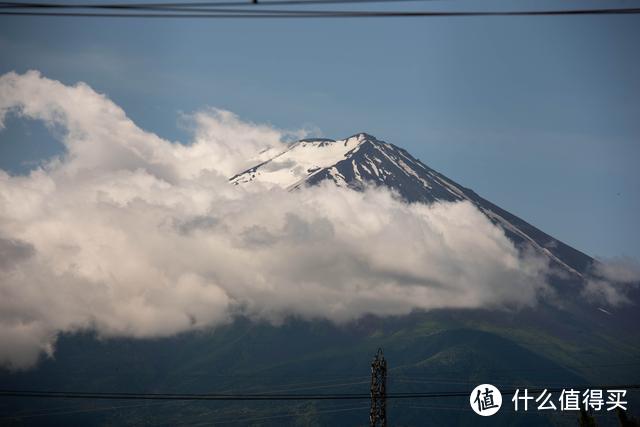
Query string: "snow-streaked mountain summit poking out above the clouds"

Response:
xmin=230 ymin=133 xmax=593 ymax=278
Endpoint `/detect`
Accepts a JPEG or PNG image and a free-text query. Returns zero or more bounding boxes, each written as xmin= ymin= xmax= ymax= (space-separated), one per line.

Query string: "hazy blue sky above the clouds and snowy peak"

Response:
xmin=0 ymin=3 xmax=640 ymax=259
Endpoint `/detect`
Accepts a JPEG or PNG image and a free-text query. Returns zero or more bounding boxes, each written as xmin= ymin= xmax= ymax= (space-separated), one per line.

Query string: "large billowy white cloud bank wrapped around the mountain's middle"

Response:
xmin=0 ymin=71 xmax=549 ymax=369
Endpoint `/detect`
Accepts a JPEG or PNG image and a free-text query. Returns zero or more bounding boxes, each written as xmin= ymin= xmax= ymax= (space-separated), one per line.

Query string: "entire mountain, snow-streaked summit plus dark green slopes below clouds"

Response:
xmin=0 ymin=133 xmax=640 ymax=427
